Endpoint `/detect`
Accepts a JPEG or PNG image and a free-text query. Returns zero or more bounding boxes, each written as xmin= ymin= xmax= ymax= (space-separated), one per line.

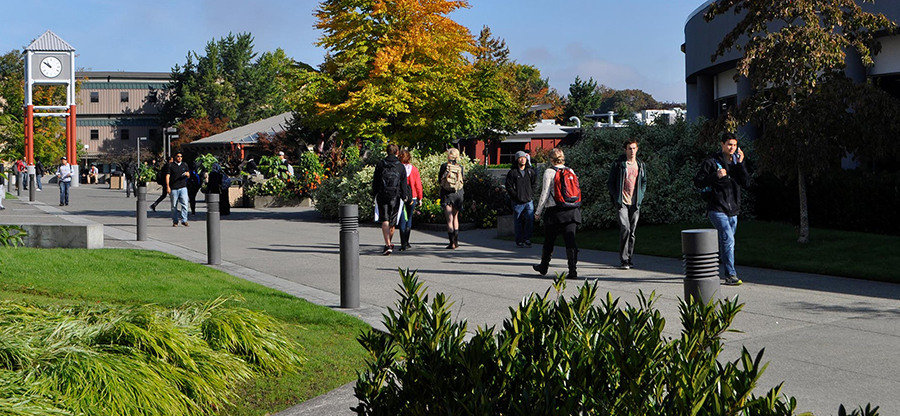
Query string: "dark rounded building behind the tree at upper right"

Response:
xmin=681 ymin=0 xmax=900 ymax=127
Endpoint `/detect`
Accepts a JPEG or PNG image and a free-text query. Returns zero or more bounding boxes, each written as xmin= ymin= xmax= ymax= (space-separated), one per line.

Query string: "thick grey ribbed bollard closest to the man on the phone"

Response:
xmin=681 ymin=228 xmax=720 ymax=303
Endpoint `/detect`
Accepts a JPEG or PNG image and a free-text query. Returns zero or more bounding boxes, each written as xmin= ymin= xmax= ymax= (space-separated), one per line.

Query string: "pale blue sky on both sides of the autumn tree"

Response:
xmin=0 ymin=0 xmax=704 ymax=102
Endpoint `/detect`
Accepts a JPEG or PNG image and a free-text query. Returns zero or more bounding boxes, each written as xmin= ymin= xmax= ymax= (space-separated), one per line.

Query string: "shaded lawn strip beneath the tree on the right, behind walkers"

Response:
xmin=533 ymin=221 xmax=900 ymax=282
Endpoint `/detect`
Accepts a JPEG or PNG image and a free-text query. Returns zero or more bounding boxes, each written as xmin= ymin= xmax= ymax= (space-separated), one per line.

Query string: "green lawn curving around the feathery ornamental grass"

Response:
xmin=0 ymin=247 xmax=369 ymax=415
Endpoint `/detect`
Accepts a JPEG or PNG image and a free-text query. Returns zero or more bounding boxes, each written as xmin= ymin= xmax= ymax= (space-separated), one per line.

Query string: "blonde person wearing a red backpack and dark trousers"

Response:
xmin=532 ymin=148 xmax=581 ymax=279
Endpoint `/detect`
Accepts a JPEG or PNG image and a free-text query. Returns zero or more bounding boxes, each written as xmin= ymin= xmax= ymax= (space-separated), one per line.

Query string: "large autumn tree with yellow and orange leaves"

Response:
xmin=295 ymin=0 xmax=524 ymax=149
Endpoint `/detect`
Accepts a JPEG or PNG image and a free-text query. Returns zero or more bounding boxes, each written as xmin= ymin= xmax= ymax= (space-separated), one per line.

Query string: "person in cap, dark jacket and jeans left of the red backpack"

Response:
xmin=506 ymin=150 xmax=537 ymax=248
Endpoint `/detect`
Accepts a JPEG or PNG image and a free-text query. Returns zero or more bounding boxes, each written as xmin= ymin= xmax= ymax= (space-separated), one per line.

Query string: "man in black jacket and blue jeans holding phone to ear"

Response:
xmin=694 ymin=133 xmax=750 ymax=286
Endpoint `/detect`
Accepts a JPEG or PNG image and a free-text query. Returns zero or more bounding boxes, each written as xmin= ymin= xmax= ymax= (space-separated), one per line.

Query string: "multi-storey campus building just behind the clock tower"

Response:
xmin=75 ymin=71 xmax=171 ymax=167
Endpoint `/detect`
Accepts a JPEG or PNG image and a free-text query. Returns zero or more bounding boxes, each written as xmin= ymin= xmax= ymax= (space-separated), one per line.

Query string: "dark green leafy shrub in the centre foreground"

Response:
xmin=354 ymin=271 xmax=877 ymax=416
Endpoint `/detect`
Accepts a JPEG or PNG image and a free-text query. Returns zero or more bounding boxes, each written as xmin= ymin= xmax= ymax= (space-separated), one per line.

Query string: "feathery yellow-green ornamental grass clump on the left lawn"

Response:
xmin=0 ymin=298 xmax=302 ymax=415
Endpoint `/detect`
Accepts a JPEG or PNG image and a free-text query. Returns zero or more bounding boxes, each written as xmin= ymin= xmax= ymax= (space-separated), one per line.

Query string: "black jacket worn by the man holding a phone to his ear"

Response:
xmin=694 ymin=152 xmax=750 ymax=217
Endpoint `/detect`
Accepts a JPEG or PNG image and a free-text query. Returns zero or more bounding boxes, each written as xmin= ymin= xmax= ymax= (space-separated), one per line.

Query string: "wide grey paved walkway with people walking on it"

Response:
xmin=0 ymin=185 xmax=900 ymax=416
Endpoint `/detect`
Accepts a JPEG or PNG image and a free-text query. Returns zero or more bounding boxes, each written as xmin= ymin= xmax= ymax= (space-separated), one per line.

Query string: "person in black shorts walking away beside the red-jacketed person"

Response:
xmin=372 ymin=143 xmax=410 ymax=256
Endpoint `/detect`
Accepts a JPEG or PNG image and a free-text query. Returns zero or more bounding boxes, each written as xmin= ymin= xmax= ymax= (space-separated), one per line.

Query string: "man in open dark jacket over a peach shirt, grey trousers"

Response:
xmin=606 ymin=139 xmax=647 ymax=270
